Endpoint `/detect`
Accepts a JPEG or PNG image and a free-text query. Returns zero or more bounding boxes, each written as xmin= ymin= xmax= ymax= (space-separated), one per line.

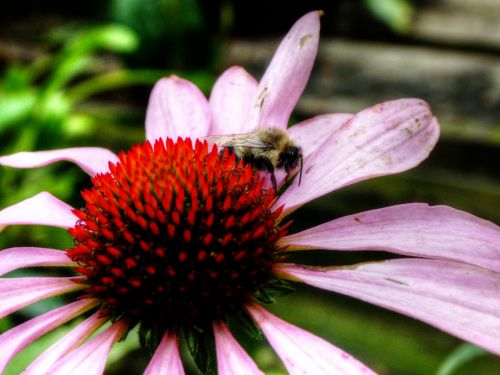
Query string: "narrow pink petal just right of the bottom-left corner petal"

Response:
xmin=23 ymin=311 xmax=108 ymax=375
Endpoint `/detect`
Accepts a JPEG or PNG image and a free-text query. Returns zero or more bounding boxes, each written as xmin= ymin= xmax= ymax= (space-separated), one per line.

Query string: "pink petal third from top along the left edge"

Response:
xmin=0 ymin=247 xmax=75 ymax=276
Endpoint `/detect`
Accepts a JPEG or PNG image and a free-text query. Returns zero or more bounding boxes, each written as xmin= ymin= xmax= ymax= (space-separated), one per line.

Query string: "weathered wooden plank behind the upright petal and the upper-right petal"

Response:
xmin=225 ymin=39 xmax=500 ymax=145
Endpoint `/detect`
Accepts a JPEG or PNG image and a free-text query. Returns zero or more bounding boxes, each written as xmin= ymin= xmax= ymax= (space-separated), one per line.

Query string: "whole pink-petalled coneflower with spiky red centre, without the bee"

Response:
xmin=0 ymin=12 xmax=500 ymax=374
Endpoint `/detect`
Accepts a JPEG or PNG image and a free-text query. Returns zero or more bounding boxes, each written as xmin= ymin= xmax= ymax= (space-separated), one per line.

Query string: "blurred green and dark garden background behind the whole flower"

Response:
xmin=0 ymin=0 xmax=500 ymax=375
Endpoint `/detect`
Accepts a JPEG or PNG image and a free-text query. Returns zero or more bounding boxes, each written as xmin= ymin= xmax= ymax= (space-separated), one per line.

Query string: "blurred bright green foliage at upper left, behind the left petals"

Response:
xmin=0 ymin=25 xmax=162 ymax=220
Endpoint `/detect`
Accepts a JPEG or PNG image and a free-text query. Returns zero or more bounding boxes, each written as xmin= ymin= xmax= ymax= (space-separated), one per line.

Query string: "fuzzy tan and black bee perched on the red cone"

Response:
xmin=204 ymin=127 xmax=303 ymax=191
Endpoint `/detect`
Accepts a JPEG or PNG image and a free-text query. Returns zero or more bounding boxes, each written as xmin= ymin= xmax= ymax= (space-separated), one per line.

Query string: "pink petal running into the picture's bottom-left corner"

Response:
xmin=0 ymin=299 xmax=97 ymax=373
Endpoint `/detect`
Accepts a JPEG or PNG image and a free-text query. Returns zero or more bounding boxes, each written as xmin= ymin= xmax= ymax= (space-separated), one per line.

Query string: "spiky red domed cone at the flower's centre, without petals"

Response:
xmin=67 ymin=139 xmax=286 ymax=330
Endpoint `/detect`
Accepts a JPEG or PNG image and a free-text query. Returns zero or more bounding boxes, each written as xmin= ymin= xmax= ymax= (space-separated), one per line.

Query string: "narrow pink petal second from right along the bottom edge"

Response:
xmin=214 ymin=322 xmax=264 ymax=375
